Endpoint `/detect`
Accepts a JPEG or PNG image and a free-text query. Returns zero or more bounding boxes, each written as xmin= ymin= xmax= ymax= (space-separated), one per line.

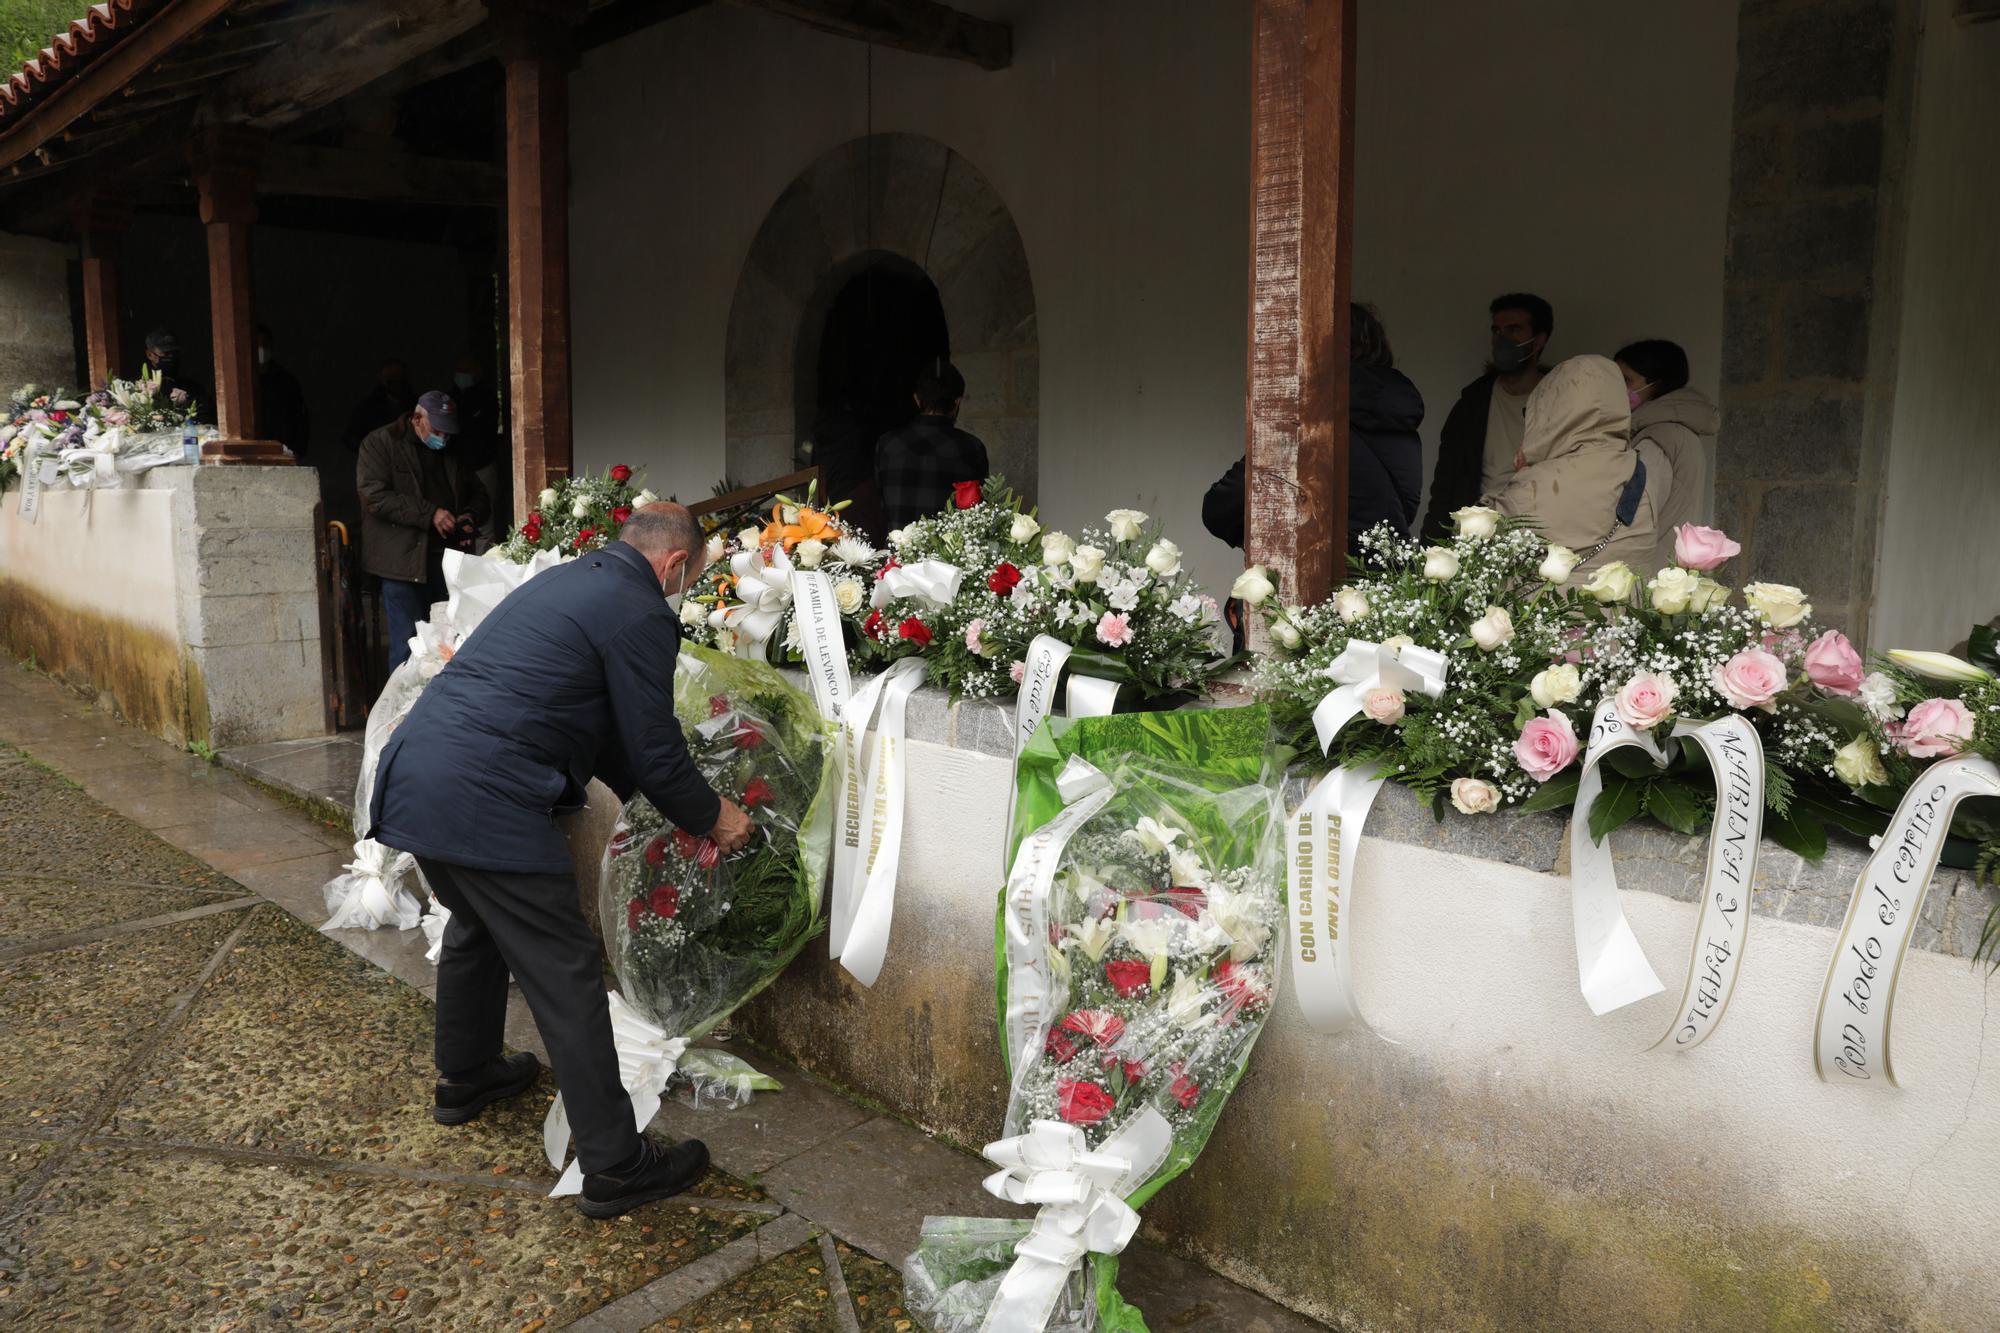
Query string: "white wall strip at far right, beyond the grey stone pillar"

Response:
xmin=1872 ymin=0 xmax=2000 ymax=648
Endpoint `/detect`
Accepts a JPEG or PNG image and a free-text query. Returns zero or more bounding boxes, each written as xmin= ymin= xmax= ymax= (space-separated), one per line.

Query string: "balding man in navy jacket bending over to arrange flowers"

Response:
xmin=370 ymin=502 xmax=752 ymax=1217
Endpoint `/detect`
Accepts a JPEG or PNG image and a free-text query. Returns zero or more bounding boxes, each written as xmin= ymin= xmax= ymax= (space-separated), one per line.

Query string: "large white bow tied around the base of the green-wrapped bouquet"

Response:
xmin=980 ymin=1107 xmax=1174 ymax=1333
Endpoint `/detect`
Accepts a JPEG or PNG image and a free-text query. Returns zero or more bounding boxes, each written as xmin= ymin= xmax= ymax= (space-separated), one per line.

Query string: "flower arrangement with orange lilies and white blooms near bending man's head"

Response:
xmin=680 ymin=484 xmax=882 ymax=664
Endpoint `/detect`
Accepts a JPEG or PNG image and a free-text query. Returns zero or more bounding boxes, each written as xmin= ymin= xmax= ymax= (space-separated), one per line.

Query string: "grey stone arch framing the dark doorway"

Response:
xmin=722 ymin=134 xmax=1042 ymax=500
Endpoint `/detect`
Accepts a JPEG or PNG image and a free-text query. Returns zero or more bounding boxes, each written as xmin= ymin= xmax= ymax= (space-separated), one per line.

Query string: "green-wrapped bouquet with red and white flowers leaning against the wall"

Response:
xmin=906 ymin=707 xmax=1284 ymax=1333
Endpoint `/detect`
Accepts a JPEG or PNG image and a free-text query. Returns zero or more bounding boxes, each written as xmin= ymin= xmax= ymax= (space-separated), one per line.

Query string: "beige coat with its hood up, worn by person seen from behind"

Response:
xmin=1486 ymin=356 xmax=1674 ymax=582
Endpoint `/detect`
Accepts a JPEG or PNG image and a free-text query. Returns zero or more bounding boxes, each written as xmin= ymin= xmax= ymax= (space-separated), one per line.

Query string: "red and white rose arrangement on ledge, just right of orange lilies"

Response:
xmin=862 ymin=476 xmax=1230 ymax=707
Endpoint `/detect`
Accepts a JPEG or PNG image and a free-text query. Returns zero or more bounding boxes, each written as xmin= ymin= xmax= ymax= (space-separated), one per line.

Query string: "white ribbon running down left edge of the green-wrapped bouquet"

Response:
xmin=1002 ymin=755 xmax=1112 ymax=1083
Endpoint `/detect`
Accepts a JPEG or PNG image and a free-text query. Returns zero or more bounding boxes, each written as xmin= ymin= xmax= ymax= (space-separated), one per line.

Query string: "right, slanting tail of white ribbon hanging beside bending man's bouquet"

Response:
xmin=828 ymin=656 xmax=924 ymax=987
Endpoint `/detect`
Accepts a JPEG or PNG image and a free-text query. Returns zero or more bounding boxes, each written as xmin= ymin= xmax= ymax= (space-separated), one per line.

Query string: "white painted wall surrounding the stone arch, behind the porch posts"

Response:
xmin=570 ymin=0 xmax=1736 ymax=588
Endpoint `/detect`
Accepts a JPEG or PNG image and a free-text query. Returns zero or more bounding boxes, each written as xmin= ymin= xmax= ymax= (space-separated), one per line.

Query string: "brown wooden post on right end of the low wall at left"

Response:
xmin=194 ymin=128 xmax=266 ymax=452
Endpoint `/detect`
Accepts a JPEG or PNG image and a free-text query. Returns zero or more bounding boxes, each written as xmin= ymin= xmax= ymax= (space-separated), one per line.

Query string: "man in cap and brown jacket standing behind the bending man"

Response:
xmin=354 ymin=388 xmax=492 ymax=671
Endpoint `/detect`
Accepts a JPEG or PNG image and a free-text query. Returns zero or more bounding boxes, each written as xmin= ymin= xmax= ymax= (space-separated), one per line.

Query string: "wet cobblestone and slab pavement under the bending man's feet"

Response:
xmin=0 ymin=669 xmax=1318 ymax=1333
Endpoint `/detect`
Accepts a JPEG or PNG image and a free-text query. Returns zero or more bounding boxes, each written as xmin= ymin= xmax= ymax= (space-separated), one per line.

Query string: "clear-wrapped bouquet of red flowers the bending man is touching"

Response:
xmin=598 ymin=646 xmax=836 ymax=1039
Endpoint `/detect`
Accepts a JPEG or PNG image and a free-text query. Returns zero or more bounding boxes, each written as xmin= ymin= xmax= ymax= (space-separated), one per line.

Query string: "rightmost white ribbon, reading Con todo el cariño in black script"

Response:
xmin=1812 ymin=757 xmax=2000 ymax=1087
